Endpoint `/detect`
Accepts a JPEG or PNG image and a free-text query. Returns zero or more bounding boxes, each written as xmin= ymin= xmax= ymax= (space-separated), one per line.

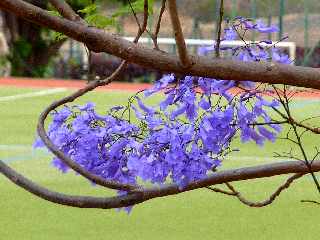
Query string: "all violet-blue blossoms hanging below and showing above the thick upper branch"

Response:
xmin=35 ymin=18 xmax=289 ymax=206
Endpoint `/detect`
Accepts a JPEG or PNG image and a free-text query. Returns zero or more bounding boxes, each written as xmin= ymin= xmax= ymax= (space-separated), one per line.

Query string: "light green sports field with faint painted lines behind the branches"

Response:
xmin=0 ymin=87 xmax=320 ymax=240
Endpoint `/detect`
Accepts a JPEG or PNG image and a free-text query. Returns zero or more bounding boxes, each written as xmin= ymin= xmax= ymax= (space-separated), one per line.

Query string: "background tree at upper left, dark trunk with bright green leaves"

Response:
xmin=1 ymin=0 xmax=136 ymax=77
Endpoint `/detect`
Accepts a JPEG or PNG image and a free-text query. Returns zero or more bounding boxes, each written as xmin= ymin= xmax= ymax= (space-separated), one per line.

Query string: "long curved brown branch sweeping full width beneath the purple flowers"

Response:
xmin=0 ymin=160 xmax=320 ymax=208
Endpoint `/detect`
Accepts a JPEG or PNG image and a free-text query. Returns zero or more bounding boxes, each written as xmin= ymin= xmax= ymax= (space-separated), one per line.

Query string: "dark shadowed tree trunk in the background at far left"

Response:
xmin=2 ymin=0 xmax=64 ymax=77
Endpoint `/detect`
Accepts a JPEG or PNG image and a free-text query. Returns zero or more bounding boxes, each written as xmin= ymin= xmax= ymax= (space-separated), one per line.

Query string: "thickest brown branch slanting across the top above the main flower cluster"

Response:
xmin=0 ymin=0 xmax=320 ymax=89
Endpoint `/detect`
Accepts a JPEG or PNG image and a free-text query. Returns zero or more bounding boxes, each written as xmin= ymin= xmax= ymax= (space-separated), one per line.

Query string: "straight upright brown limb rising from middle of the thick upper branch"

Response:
xmin=168 ymin=0 xmax=191 ymax=68
